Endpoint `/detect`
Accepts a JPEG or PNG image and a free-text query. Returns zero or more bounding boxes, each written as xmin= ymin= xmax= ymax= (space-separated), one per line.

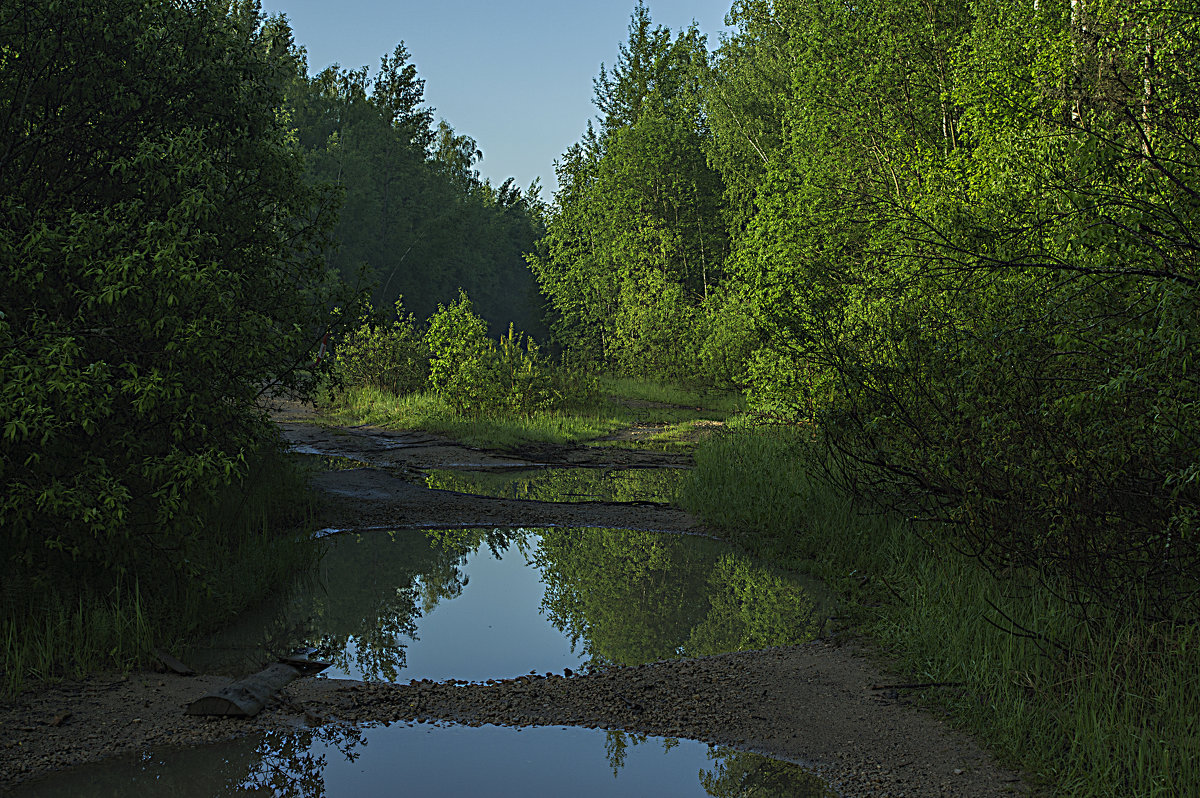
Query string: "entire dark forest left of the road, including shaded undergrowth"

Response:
xmin=0 ymin=0 xmax=545 ymax=689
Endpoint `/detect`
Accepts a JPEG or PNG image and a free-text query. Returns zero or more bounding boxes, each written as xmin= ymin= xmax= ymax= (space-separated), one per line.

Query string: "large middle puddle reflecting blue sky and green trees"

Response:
xmin=185 ymin=528 xmax=833 ymax=682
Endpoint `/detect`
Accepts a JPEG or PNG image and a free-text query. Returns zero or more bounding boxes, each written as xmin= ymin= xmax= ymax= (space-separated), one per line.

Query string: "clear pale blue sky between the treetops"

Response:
xmin=263 ymin=0 xmax=732 ymax=200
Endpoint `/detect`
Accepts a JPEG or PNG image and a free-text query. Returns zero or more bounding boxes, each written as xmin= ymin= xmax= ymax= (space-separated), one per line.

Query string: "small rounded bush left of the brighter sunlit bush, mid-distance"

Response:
xmin=334 ymin=299 xmax=430 ymax=394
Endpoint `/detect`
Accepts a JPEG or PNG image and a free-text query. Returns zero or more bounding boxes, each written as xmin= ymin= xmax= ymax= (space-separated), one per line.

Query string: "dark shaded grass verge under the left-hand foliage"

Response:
xmin=0 ymin=444 xmax=319 ymax=696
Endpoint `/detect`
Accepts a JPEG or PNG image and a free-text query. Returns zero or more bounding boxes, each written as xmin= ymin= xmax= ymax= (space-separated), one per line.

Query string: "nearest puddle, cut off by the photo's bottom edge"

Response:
xmin=13 ymin=724 xmax=835 ymax=798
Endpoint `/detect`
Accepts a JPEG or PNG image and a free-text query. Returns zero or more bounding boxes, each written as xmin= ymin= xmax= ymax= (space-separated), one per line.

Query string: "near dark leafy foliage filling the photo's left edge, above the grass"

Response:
xmin=0 ymin=0 xmax=347 ymax=624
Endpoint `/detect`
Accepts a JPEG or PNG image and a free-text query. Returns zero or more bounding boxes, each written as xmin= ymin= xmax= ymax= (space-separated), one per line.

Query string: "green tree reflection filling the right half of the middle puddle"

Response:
xmin=534 ymin=529 xmax=820 ymax=665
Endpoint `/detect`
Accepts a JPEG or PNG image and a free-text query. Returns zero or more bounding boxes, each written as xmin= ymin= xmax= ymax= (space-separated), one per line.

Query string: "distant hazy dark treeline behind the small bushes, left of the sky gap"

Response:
xmin=268 ymin=18 xmax=545 ymax=335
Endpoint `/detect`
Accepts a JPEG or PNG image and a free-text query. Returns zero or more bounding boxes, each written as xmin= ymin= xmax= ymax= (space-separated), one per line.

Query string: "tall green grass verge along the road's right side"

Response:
xmin=683 ymin=428 xmax=1200 ymax=797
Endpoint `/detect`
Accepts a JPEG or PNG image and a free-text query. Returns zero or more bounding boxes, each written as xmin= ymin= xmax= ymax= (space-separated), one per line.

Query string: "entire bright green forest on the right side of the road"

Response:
xmin=532 ymin=0 xmax=1200 ymax=617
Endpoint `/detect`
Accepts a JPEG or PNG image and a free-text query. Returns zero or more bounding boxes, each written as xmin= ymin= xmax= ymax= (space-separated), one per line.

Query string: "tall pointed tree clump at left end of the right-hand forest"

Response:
xmin=529 ymin=4 xmax=728 ymax=379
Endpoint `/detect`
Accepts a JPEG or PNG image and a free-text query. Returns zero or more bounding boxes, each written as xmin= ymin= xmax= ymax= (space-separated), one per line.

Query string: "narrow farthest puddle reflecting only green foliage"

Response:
xmin=425 ymin=468 xmax=686 ymax=504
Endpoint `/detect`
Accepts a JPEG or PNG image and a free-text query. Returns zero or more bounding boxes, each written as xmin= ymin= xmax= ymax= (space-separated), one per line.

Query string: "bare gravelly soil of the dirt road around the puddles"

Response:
xmin=0 ymin=406 xmax=1028 ymax=796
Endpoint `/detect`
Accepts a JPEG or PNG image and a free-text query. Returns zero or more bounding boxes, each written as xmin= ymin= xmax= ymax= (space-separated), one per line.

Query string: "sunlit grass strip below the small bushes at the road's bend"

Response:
xmin=322 ymin=378 xmax=740 ymax=449
